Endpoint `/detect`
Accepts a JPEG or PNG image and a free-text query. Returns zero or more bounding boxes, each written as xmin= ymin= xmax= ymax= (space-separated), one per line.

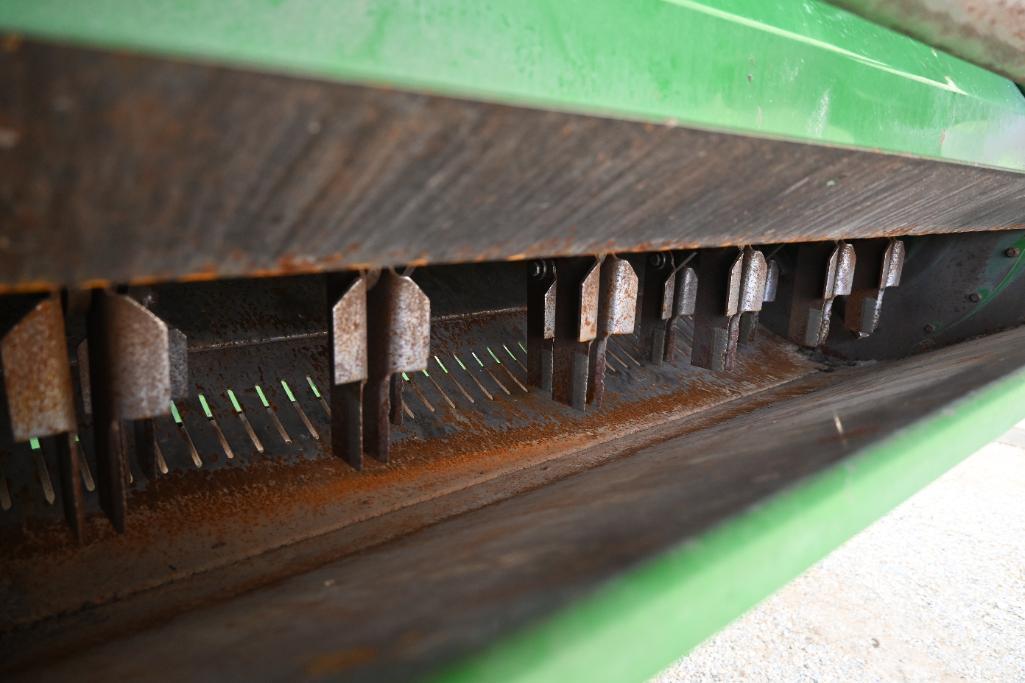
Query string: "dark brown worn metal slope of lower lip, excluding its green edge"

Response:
xmin=12 ymin=330 xmax=1025 ymax=681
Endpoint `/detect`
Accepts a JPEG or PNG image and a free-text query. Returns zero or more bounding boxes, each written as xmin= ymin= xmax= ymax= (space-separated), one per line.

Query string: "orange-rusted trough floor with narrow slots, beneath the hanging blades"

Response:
xmin=0 ymin=313 xmax=817 ymax=648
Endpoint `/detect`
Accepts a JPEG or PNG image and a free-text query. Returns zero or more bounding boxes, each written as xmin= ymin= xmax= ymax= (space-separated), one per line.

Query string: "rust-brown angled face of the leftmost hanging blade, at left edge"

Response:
xmin=0 ymin=297 xmax=76 ymax=441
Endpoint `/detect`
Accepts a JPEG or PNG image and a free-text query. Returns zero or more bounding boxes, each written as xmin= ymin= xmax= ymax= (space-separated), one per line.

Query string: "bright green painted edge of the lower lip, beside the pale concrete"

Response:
xmin=435 ymin=372 xmax=1025 ymax=683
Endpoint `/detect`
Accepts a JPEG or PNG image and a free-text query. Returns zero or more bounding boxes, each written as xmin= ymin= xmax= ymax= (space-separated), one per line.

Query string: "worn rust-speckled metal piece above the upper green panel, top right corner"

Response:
xmin=828 ymin=0 xmax=1025 ymax=83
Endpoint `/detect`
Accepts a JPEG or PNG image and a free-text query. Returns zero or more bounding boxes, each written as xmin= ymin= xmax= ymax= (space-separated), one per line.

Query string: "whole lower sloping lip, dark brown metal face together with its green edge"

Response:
xmin=14 ymin=330 xmax=1025 ymax=681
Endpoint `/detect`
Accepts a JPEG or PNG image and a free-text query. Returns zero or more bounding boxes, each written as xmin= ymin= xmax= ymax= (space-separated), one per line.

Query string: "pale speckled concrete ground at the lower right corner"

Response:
xmin=654 ymin=423 xmax=1025 ymax=683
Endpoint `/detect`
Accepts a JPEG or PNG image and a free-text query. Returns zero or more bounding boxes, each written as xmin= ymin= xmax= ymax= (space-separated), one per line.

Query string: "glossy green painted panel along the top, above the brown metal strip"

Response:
xmin=6 ymin=0 xmax=1025 ymax=170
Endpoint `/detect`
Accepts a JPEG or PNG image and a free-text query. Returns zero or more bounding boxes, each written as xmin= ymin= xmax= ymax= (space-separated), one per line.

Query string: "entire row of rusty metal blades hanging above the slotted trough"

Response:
xmin=0 ymin=239 xmax=904 ymax=539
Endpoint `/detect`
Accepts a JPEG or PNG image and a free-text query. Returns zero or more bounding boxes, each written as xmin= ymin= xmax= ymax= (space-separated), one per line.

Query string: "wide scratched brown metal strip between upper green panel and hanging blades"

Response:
xmin=0 ymin=40 xmax=1025 ymax=289
